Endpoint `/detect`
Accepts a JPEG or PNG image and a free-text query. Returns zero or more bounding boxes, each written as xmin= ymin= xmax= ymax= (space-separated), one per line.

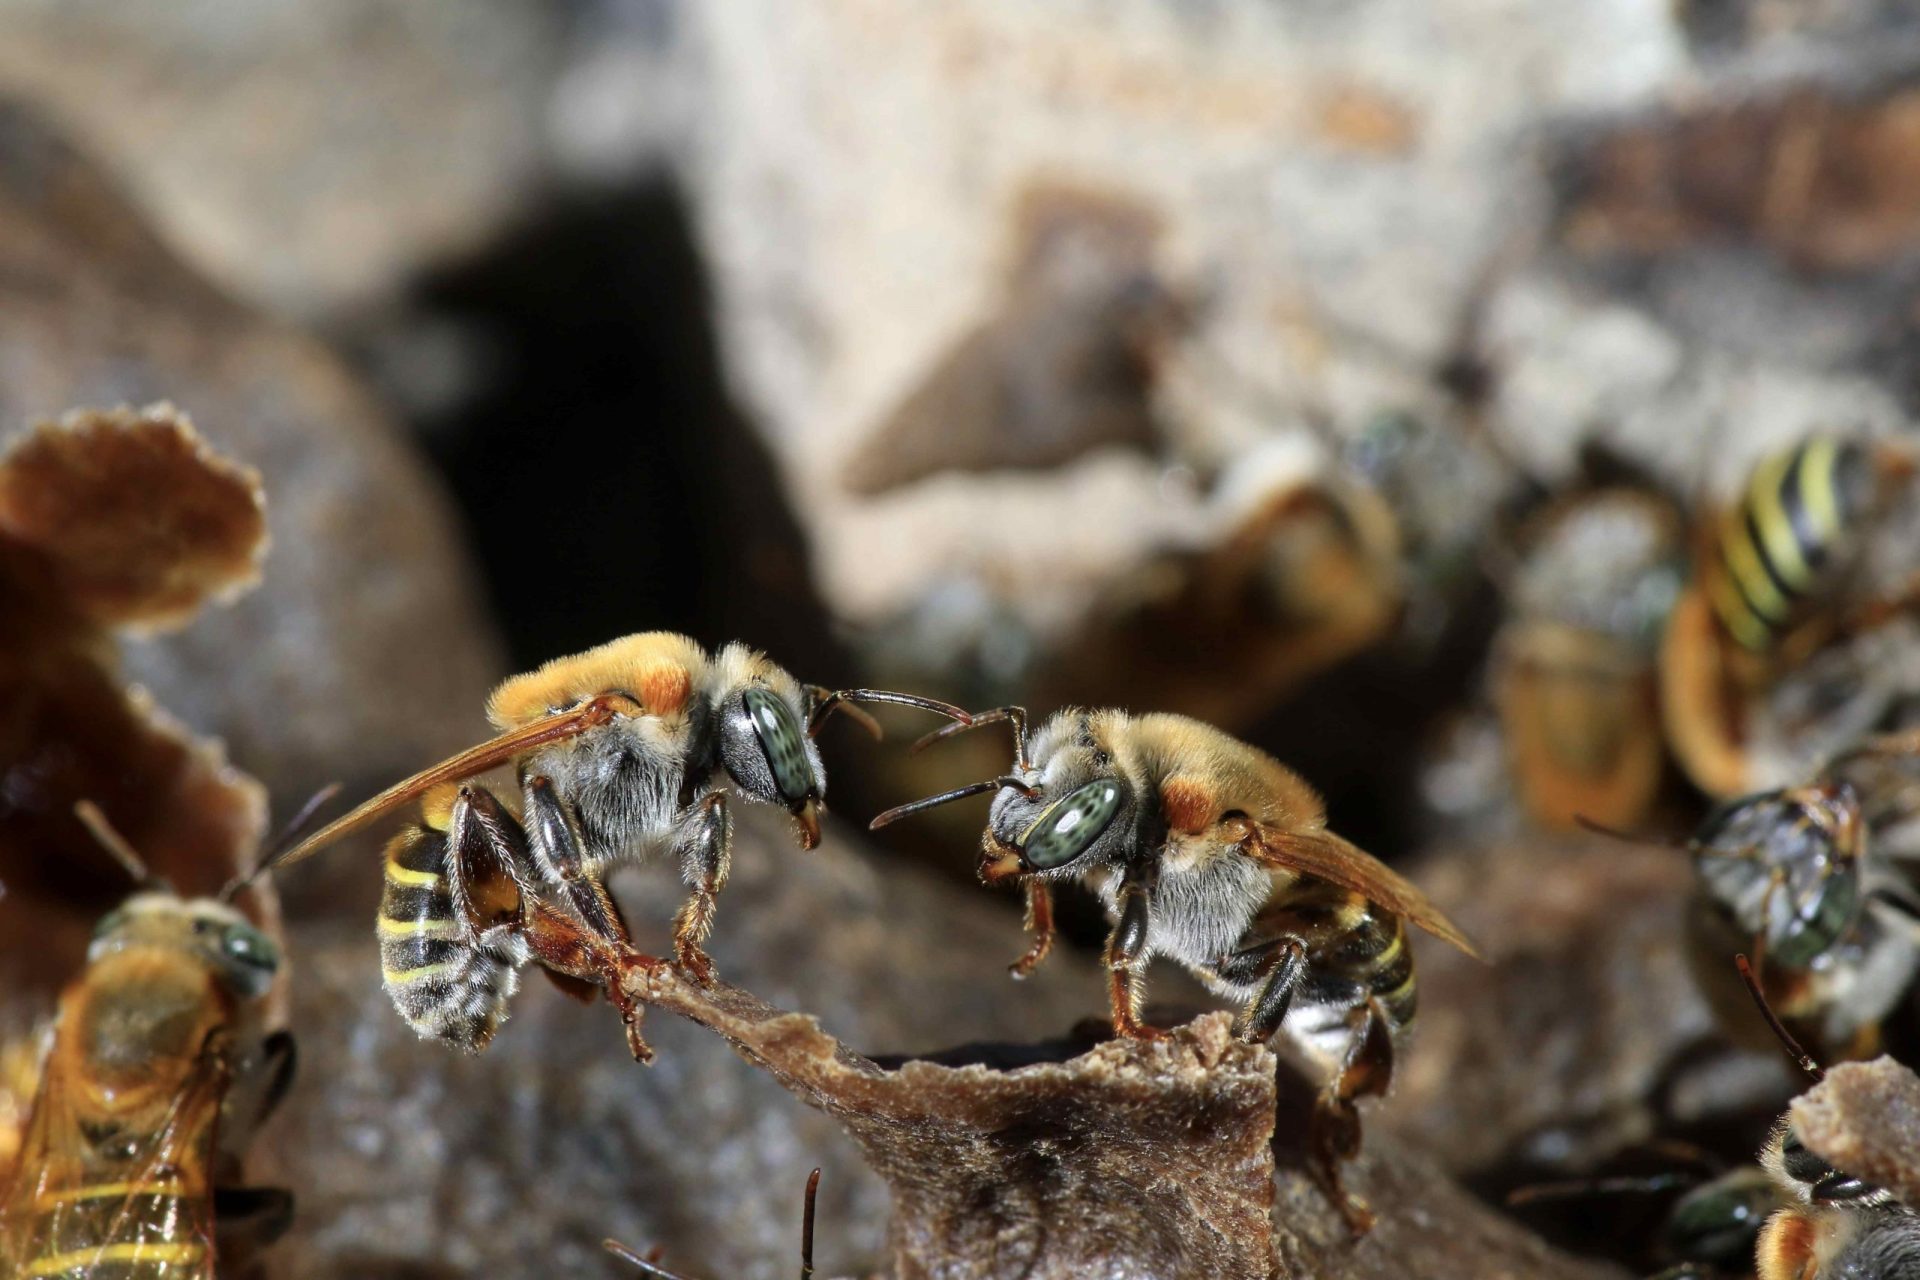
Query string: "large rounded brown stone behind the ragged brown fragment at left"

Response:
xmin=0 ymin=105 xmax=499 ymax=817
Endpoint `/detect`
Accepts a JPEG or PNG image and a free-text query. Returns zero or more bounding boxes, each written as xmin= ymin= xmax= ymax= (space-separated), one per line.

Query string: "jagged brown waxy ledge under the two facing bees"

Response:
xmin=626 ymin=969 xmax=1275 ymax=1280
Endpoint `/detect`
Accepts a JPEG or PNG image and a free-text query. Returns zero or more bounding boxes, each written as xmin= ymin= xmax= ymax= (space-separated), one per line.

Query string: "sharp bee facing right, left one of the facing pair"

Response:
xmin=286 ymin=631 xmax=966 ymax=1005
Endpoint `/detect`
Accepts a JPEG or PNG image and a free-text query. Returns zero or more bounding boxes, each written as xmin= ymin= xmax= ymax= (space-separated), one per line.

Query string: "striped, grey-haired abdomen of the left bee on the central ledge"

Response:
xmin=378 ymin=827 xmax=526 ymax=1054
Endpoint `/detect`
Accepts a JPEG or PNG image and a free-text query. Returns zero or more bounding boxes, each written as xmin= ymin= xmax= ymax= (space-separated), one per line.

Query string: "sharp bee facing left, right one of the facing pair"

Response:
xmin=874 ymin=706 xmax=1476 ymax=1230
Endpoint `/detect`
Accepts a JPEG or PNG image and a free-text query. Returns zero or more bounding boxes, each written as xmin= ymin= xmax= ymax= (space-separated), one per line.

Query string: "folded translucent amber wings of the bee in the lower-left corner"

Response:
xmin=0 ymin=1052 xmax=230 ymax=1280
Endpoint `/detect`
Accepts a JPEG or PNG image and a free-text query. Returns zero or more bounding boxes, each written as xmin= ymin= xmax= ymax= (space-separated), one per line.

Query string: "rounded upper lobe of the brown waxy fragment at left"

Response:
xmin=0 ymin=405 xmax=267 ymax=628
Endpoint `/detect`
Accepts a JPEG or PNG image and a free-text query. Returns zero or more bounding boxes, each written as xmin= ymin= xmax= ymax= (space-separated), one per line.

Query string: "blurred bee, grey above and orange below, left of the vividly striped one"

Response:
xmin=1492 ymin=487 xmax=1684 ymax=827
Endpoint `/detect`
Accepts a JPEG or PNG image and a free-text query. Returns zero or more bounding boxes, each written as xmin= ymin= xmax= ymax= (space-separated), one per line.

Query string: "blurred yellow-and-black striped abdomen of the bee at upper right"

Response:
xmin=1707 ymin=436 xmax=1872 ymax=652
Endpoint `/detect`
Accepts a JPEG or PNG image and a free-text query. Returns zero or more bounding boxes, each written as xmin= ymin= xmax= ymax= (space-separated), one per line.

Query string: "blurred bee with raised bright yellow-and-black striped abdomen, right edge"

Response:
xmin=1659 ymin=436 xmax=1914 ymax=796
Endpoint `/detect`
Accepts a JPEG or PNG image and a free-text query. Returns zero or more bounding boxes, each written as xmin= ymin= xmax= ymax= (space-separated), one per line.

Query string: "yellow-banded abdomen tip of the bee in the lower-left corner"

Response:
xmin=19 ymin=1176 xmax=213 ymax=1280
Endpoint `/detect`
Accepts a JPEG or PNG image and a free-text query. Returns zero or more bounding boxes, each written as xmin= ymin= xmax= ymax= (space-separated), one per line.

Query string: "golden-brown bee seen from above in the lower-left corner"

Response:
xmin=0 ymin=804 xmax=294 ymax=1280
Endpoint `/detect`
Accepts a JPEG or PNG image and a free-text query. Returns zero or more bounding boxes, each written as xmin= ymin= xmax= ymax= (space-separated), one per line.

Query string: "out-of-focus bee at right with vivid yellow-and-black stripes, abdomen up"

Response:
xmin=1659 ymin=436 xmax=1916 ymax=798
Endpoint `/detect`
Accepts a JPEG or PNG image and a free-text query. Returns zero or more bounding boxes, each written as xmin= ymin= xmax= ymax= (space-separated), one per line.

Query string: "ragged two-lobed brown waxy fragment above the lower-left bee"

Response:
xmin=0 ymin=405 xmax=275 ymax=1007
